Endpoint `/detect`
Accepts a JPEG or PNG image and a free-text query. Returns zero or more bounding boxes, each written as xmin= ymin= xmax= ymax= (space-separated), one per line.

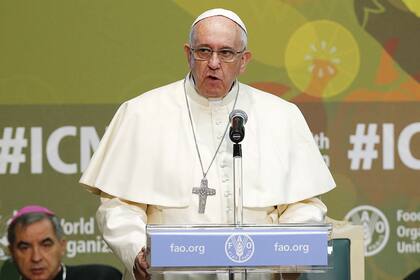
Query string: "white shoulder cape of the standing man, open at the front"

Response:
xmin=80 ymin=77 xmax=335 ymax=207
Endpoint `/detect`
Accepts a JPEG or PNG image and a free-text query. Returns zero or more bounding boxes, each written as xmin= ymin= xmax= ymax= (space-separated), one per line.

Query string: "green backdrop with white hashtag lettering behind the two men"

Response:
xmin=0 ymin=0 xmax=420 ymax=280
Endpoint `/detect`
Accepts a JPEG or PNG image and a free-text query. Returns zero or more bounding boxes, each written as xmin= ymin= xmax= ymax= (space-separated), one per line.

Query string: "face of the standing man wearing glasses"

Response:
xmin=184 ymin=16 xmax=251 ymax=98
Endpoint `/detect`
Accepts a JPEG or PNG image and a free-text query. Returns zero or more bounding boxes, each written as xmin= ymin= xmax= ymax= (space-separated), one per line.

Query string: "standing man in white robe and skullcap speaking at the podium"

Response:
xmin=80 ymin=9 xmax=335 ymax=279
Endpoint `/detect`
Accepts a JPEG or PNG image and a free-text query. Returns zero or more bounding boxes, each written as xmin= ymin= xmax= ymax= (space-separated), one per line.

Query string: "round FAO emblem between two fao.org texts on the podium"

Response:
xmin=225 ymin=234 xmax=254 ymax=263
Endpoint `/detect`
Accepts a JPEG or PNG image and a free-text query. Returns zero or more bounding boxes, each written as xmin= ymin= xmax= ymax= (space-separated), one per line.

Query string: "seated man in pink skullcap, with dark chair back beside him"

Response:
xmin=7 ymin=205 xmax=121 ymax=280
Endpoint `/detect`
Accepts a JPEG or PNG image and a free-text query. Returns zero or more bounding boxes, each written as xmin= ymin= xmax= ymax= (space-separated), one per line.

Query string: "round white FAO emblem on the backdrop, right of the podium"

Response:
xmin=345 ymin=205 xmax=389 ymax=257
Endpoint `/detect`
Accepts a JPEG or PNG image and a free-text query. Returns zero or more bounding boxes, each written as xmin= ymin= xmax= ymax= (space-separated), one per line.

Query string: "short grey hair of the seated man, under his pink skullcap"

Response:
xmin=7 ymin=212 xmax=64 ymax=245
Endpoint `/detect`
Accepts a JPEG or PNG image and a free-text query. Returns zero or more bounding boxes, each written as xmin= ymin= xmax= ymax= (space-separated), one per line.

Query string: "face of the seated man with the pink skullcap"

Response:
xmin=9 ymin=219 xmax=66 ymax=280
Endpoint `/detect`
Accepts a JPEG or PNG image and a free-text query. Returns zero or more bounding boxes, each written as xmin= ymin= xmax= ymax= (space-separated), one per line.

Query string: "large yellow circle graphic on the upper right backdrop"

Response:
xmin=285 ymin=20 xmax=360 ymax=98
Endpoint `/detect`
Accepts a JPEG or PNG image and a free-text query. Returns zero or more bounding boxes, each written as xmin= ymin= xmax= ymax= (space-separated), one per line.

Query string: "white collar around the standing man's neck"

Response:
xmin=185 ymin=73 xmax=238 ymax=107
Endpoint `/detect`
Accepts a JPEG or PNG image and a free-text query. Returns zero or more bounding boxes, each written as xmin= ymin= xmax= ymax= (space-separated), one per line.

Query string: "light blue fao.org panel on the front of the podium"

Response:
xmin=146 ymin=224 xmax=333 ymax=274
